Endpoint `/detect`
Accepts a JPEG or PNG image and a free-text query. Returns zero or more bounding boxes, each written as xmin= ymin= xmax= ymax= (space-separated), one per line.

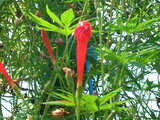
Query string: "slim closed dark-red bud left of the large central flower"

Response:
xmin=41 ymin=29 xmax=56 ymax=64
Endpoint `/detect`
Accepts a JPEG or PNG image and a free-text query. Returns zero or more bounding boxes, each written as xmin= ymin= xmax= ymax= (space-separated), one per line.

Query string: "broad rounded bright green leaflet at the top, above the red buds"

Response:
xmin=61 ymin=9 xmax=75 ymax=25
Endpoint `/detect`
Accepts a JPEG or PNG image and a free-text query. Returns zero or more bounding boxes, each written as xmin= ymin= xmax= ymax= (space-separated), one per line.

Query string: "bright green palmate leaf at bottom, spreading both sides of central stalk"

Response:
xmin=43 ymin=88 xmax=131 ymax=112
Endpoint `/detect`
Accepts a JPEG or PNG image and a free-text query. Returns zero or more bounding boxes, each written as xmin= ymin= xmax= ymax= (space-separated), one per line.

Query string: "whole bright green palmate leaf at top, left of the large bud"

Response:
xmin=28 ymin=5 xmax=75 ymax=36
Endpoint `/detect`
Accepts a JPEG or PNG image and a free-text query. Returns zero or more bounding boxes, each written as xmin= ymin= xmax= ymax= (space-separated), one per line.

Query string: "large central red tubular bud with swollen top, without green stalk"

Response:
xmin=74 ymin=21 xmax=92 ymax=87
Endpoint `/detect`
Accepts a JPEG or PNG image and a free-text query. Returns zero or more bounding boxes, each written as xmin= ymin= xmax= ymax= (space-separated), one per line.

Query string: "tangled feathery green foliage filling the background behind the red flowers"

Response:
xmin=0 ymin=0 xmax=160 ymax=120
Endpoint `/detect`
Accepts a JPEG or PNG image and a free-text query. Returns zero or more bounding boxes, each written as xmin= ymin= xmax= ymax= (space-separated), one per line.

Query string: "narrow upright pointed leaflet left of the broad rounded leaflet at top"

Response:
xmin=46 ymin=5 xmax=64 ymax=28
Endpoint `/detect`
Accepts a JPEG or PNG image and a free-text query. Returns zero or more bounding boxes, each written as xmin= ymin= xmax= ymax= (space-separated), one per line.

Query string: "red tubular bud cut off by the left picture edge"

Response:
xmin=0 ymin=61 xmax=15 ymax=88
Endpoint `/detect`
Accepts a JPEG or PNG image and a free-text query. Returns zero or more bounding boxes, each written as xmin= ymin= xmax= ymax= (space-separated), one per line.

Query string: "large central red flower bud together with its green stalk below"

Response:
xmin=74 ymin=21 xmax=92 ymax=120
